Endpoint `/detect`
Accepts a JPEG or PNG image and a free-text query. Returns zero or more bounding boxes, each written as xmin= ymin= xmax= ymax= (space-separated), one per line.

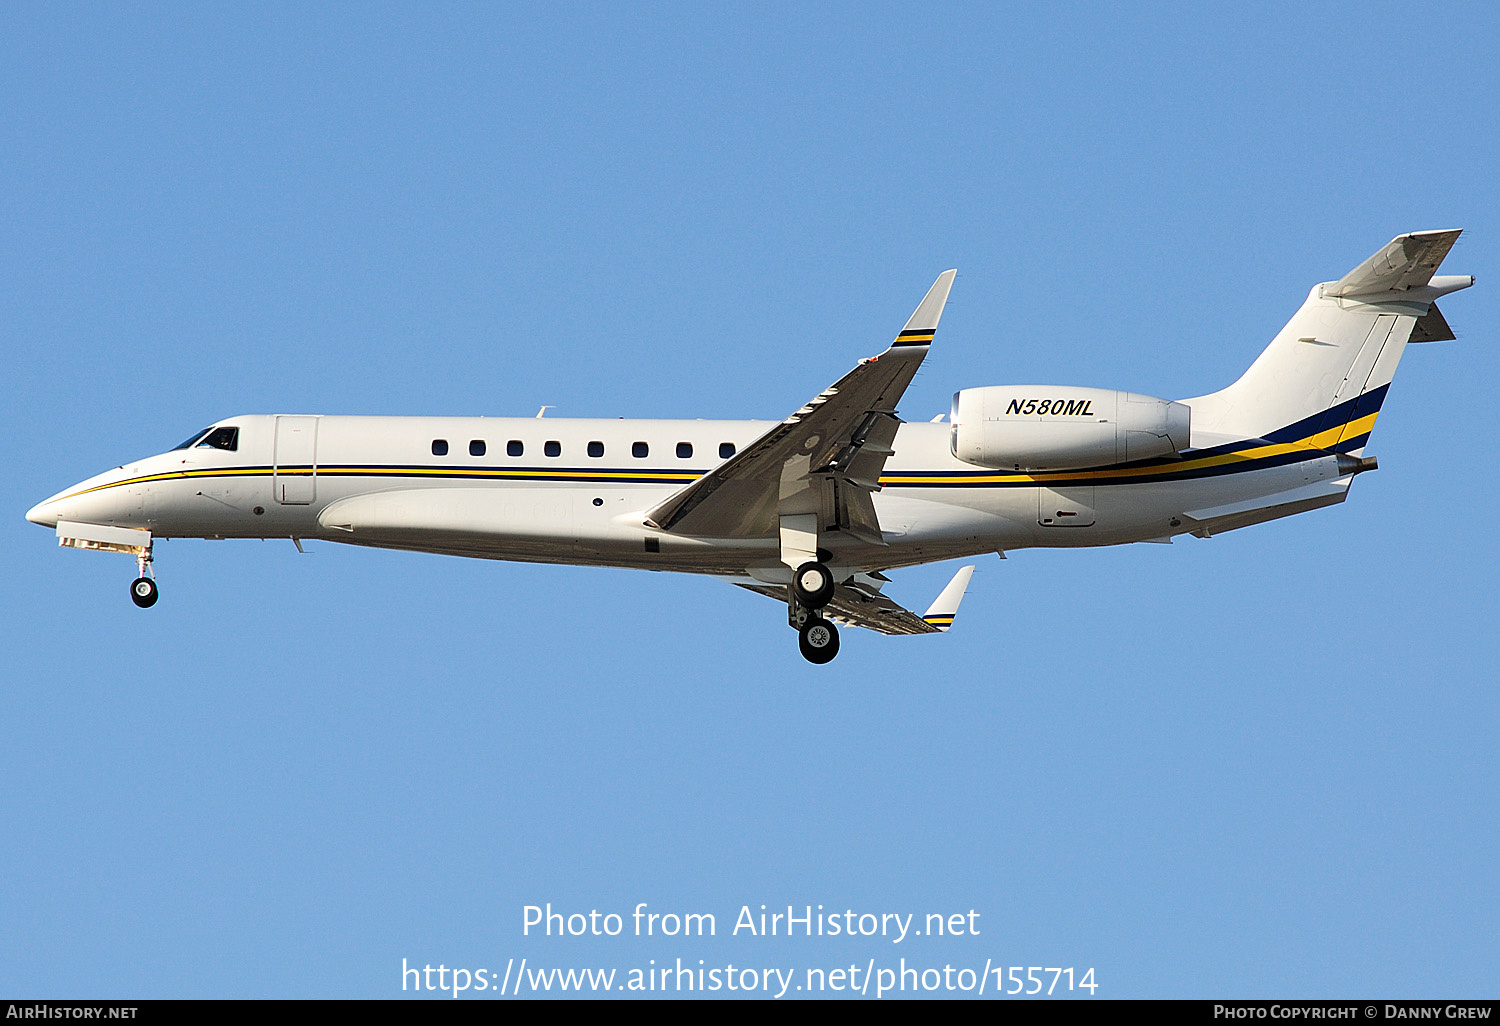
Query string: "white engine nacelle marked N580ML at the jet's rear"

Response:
xmin=951 ymin=386 xmax=1193 ymax=471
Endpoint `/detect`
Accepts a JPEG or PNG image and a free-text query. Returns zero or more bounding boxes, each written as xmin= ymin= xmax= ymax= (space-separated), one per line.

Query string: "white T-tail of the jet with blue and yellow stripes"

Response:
xmin=1184 ymin=230 xmax=1475 ymax=458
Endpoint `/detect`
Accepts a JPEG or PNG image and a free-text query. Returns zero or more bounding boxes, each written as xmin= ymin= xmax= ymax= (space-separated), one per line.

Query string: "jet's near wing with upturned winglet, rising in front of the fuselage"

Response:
xmin=647 ymin=270 xmax=959 ymax=545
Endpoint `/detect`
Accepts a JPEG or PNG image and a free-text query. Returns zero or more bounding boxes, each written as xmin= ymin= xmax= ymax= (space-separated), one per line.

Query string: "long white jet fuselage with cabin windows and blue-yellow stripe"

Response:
xmin=29 ymin=416 xmax=1349 ymax=573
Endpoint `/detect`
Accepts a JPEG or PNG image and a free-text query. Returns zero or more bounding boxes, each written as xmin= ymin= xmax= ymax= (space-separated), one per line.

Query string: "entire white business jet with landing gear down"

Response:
xmin=27 ymin=231 xmax=1475 ymax=663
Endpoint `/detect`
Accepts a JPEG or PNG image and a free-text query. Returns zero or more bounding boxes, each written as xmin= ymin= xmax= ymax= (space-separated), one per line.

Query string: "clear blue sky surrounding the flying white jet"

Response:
xmin=0 ymin=3 xmax=1500 ymax=998
